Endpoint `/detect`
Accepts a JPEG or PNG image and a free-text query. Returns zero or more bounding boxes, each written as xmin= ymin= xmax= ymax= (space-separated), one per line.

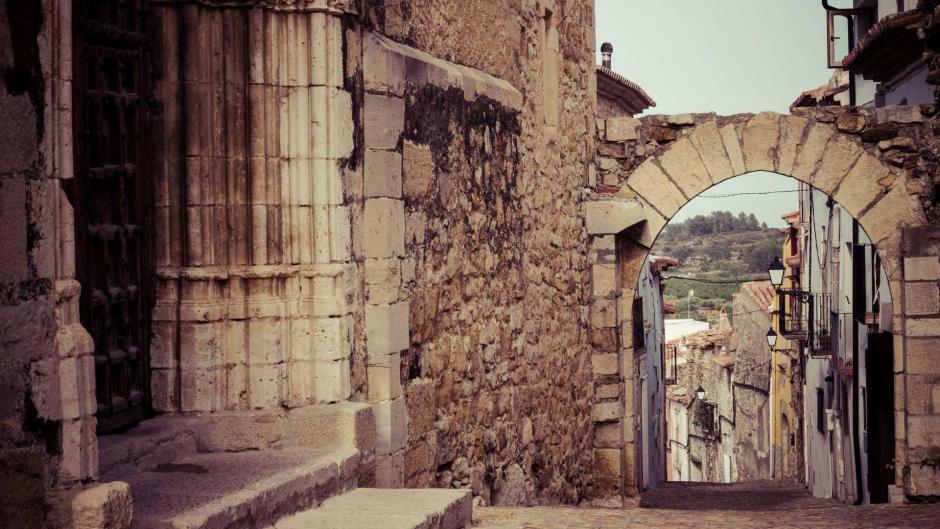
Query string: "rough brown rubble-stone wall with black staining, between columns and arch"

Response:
xmin=353 ymin=1 xmax=593 ymax=504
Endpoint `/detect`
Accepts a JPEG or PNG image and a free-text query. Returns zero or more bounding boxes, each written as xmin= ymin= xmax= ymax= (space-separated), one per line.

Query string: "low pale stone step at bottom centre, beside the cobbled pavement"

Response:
xmin=269 ymin=489 xmax=473 ymax=529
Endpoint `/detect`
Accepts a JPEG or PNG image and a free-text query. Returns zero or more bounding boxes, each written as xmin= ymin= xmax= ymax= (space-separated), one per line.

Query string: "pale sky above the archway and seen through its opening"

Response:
xmin=596 ymin=0 xmax=848 ymax=226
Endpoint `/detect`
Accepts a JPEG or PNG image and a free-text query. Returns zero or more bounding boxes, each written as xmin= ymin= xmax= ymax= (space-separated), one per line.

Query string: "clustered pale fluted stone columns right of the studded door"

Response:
xmin=151 ymin=0 xmax=354 ymax=412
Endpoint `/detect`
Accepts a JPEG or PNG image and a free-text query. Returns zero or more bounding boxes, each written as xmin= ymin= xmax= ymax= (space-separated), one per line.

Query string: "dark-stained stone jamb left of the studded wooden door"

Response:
xmin=0 ymin=1 xmax=103 ymax=527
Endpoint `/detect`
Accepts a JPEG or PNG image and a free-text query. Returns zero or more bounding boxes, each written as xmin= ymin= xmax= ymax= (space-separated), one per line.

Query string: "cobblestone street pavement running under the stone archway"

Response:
xmin=473 ymin=481 xmax=940 ymax=529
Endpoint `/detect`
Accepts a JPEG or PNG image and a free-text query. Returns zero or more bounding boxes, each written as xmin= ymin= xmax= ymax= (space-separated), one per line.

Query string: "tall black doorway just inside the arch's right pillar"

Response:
xmin=865 ymin=332 xmax=894 ymax=503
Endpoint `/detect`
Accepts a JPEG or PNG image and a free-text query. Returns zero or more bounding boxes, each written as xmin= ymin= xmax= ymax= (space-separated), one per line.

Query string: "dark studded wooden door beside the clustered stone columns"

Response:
xmin=66 ymin=0 xmax=150 ymax=433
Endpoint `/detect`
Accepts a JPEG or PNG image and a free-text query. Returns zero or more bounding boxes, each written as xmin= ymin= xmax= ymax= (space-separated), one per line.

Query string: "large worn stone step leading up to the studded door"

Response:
xmin=108 ymin=447 xmax=359 ymax=529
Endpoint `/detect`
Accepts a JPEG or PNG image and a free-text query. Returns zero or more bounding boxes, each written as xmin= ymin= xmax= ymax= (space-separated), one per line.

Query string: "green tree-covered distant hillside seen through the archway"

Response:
xmin=652 ymin=211 xmax=783 ymax=319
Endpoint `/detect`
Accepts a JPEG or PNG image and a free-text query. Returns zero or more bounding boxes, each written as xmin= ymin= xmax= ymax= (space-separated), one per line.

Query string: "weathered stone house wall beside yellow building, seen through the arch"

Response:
xmin=732 ymin=293 xmax=770 ymax=481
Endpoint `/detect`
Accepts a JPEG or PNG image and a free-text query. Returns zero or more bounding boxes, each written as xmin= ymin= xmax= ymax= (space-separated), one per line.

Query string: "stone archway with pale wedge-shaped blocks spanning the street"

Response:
xmin=585 ymin=107 xmax=940 ymax=495
